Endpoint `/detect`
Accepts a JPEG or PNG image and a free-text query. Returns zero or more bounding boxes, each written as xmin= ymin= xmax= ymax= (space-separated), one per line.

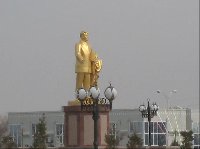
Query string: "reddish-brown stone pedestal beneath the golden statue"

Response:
xmin=63 ymin=105 xmax=109 ymax=149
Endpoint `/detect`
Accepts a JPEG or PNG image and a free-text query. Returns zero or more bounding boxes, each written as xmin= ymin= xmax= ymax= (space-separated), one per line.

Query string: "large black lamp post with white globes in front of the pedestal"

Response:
xmin=76 ymin=84 xmax=117 ymax=149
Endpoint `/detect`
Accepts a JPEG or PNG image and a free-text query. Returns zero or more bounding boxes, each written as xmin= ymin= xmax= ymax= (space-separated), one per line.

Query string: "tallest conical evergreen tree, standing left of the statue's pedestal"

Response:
xmin=33 ymin=114 xmax=47 ymax=149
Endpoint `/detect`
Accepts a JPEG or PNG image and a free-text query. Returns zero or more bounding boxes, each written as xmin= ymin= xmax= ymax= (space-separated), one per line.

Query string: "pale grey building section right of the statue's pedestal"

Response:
xmin=110 ymin=107 xmax=192 ymax=146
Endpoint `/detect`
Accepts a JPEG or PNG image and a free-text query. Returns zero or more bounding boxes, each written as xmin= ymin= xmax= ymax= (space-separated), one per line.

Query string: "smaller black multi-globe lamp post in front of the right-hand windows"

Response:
xmin=139 ymin=99 xmax=159 ymax=146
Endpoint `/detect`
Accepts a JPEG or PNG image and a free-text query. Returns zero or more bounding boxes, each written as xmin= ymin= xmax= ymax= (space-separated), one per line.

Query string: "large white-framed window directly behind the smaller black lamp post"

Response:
xmin=144 ymin=122 xmax=166 ymax=146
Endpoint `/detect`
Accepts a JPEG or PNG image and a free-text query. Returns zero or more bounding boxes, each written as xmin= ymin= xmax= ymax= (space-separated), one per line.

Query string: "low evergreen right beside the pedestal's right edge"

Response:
xmin=105 ymin=134 xmax=120 ymax=149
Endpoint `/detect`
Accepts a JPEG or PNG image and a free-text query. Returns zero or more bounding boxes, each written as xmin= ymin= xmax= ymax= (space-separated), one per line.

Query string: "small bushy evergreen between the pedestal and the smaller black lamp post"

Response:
xmin=126 ymin=133 xmax=143 ymax=149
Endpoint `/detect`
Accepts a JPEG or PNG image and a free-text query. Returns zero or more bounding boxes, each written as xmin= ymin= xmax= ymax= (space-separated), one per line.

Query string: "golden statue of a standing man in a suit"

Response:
xmin=75 ymin=31 xmax=102 ymax=90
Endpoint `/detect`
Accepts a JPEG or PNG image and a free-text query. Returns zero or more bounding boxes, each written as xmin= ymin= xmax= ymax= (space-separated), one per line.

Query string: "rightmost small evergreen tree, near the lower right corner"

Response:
xmin=180 ymin=130 xmax=194 ymax=149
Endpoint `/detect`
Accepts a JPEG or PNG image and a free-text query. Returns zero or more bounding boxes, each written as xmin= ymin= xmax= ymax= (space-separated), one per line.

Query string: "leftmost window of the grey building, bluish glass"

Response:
xmin=9 ymin=124 xmax=23 ymax=147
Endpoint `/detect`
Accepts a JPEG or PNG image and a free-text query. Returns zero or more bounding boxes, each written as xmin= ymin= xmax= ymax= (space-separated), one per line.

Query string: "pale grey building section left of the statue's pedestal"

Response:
xmin=8 ymin=111 xmax=64 ymax=147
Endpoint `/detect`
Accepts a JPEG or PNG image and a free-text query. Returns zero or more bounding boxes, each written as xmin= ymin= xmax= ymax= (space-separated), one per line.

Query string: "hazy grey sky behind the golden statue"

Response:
xmin=0 ymin=0 xmax=199 ymax=114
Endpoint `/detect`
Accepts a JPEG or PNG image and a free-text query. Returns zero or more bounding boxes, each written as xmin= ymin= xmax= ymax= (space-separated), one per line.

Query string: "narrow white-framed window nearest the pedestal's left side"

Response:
xmin=56 ymin=124 xmax=64 ymax=146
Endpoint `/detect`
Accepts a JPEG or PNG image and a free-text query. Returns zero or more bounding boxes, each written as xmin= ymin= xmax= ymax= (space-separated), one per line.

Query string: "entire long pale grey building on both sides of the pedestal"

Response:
xmin=8 ymin=107 xmax=200 ymax=147
